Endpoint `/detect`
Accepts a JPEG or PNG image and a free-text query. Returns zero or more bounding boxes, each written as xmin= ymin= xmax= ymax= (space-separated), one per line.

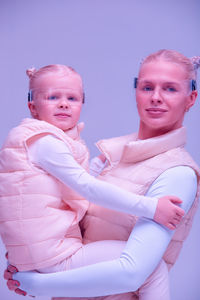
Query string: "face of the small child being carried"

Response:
xmin=29 ymin=74 xmax=83 ymax=131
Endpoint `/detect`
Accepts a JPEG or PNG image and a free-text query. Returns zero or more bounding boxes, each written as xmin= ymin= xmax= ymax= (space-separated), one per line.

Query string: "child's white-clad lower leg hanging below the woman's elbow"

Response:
xmin=139 ymin=260 xmax=170 ymax=300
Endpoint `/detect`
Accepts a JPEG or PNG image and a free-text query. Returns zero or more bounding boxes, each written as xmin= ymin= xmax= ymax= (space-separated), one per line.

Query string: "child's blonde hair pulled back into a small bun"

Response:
xmin=26 ymin=64 xmax=84 ymax=100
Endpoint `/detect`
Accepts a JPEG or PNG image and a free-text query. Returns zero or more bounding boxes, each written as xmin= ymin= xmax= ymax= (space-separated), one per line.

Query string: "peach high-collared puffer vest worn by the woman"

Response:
xmin=81 ymin=127 xmax=200 ymax=268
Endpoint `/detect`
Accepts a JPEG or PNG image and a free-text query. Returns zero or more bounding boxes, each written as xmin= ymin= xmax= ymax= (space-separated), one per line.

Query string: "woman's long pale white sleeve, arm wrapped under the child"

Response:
xmin=8 ymin=167 xmax=197 ymax=297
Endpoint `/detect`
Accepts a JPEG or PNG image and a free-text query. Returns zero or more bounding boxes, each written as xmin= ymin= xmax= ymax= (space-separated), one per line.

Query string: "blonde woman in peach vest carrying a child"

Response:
xmin=4 ymin=50 xmax=199 ymax=299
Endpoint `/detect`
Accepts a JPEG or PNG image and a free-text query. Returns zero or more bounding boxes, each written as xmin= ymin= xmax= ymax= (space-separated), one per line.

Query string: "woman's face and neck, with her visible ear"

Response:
xmin=136 ymin=60 xmax=197 ymax=139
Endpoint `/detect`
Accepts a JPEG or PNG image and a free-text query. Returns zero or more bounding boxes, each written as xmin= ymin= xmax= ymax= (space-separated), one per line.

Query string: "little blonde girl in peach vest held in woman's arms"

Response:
xmin=0 ymin=65 xmax=184 ymax=296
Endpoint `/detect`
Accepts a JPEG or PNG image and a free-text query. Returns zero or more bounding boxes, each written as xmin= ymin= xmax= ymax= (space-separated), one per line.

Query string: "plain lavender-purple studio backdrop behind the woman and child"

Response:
xmin=0 ymin=0 xmax=200 ymax=300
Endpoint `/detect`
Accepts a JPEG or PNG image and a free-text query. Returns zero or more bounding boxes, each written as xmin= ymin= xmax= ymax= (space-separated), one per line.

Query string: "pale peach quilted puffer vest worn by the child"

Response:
xmin=0 ymin=119 xmax=89 ymax=271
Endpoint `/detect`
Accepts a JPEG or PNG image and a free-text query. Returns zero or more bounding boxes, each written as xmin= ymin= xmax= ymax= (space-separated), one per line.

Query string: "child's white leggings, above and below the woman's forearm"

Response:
xmin=39 ymin=241 xmax=170 ymax=300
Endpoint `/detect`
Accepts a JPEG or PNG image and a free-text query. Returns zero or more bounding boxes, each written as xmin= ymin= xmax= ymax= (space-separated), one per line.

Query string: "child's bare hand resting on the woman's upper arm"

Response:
xmin=154 ymin=196 xmax=185 ymax=230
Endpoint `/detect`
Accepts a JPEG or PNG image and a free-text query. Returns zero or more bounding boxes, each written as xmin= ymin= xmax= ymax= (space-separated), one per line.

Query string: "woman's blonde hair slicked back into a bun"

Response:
xmin=141 ymin=49 xmax=200 ymax=80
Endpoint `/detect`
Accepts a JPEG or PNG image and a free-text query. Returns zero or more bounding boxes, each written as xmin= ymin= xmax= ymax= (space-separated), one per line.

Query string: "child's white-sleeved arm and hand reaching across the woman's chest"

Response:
xmin=29 ymin=135 xmax=184 ymax=229
